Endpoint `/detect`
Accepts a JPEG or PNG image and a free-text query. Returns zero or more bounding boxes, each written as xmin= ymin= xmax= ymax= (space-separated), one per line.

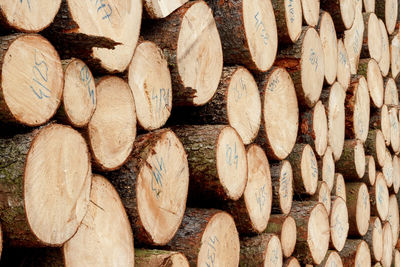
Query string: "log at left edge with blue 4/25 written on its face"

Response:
xmin=0 ymin=34 xmax=63 ymax=126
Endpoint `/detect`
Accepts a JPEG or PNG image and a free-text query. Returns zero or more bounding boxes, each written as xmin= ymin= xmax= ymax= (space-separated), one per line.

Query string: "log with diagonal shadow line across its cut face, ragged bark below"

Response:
xmin=141 ymin=1 xmax=223 ymax=106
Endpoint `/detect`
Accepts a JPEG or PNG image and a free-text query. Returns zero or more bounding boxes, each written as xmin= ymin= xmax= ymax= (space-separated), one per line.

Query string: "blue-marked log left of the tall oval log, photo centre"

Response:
xmin=171 ymin=66 xmax=262 ymax=144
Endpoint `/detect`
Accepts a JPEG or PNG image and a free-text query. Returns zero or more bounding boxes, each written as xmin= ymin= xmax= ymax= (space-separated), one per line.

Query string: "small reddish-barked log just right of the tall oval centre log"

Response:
xmin=297 ymin=101 xmax=328 ymax=157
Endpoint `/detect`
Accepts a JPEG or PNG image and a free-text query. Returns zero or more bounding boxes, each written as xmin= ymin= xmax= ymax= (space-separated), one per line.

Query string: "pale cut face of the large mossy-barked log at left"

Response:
xmin=24 ymin=124 xmax=92 ymax=246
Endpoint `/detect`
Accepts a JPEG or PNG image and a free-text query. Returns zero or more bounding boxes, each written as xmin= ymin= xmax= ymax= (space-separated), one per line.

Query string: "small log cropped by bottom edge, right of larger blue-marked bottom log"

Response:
xmin=239 ymin=233 xmax=283 ymax=267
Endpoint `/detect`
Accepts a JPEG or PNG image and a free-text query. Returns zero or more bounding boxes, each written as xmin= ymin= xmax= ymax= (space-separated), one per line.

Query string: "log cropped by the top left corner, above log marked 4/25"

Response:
xmin=0 ymin=0 xmax=61 ymax=32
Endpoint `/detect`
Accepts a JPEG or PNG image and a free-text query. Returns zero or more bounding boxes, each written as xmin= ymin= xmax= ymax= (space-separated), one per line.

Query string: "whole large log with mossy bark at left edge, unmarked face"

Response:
xmin=0 ymin=124 xmax=92 ymax=246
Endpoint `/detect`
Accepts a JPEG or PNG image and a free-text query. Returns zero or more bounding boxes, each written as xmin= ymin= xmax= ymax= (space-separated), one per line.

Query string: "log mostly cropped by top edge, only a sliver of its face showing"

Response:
xmin=143 ymin=0 xmax=188 ymax=19
